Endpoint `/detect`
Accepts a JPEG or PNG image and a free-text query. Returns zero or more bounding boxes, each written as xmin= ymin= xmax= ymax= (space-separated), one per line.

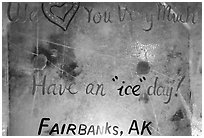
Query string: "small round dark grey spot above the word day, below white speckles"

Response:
xmin=136 ymin=61 xmax=150 ymax=75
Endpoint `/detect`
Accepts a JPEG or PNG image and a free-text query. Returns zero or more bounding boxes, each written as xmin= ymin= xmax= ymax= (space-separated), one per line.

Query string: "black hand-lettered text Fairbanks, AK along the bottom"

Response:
xmin=38 ymin=118 xmax=152 ymax=136
